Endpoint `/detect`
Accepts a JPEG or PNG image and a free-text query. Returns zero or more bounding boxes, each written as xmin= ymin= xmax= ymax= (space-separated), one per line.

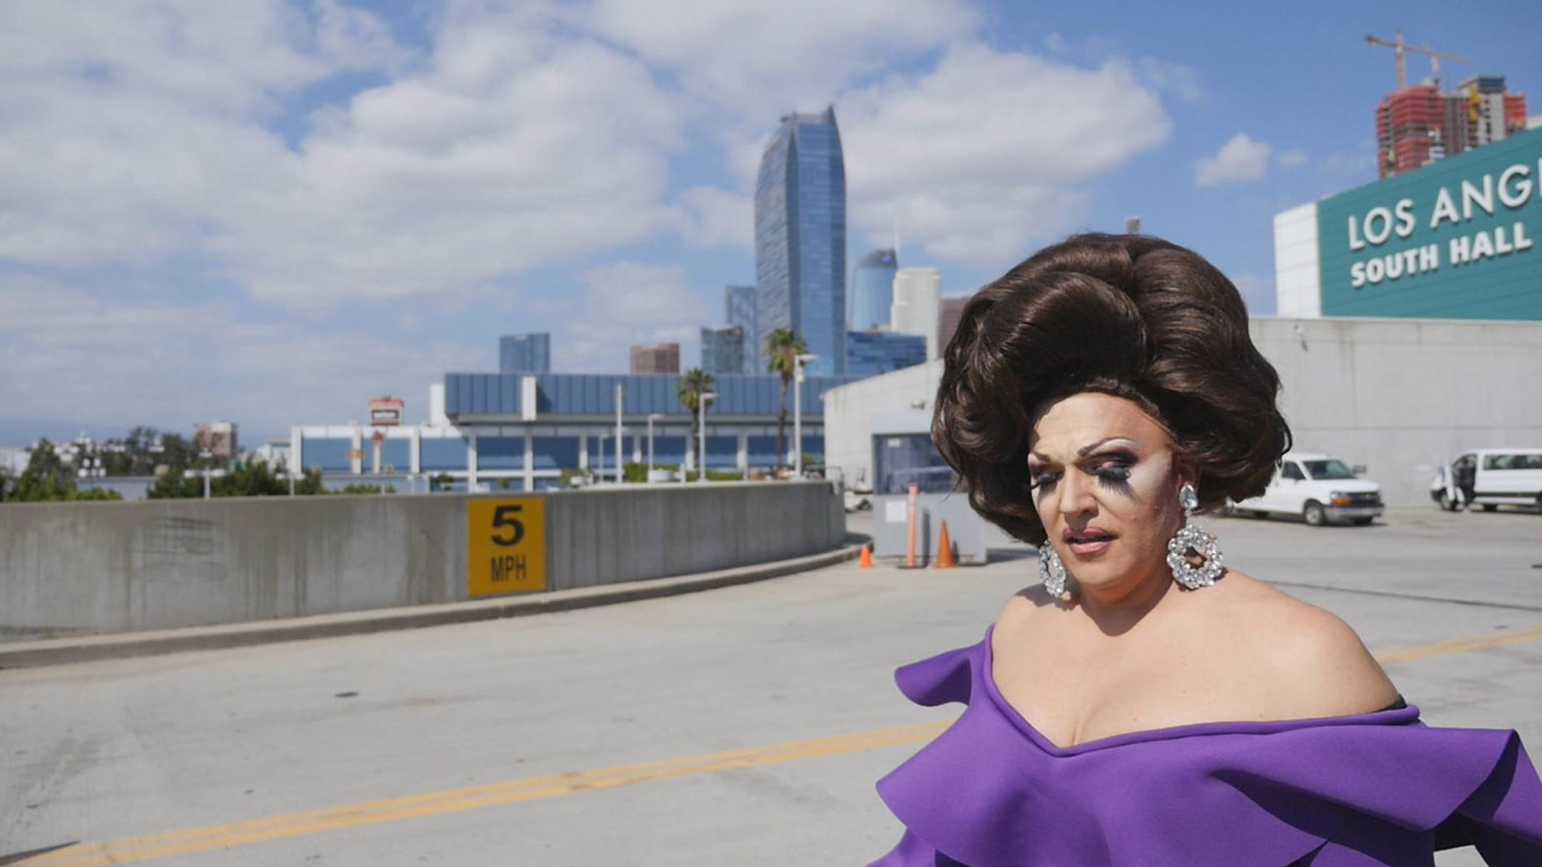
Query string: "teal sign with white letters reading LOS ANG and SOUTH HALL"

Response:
xmin=1317 ymin=130 xmax=1542 ymax=321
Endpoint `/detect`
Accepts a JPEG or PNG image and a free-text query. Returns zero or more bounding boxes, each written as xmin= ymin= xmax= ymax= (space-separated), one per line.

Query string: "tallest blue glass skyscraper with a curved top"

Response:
xmin=756 ymin=106 xmax=847 ymax=375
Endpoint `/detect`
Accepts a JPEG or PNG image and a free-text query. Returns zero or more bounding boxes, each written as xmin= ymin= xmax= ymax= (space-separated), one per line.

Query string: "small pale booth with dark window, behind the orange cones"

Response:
xmin=873 ymin=410 xmax=987 ymax=565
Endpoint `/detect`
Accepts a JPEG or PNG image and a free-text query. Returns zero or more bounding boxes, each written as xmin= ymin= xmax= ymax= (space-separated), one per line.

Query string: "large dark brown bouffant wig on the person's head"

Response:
xmin=931 ymin=234 xmax=1291 ymax=545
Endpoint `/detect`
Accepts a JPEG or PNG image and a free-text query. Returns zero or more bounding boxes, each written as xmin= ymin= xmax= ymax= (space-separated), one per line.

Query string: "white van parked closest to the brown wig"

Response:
xmin=1232 ymin=452 xmax=1385 ymax=526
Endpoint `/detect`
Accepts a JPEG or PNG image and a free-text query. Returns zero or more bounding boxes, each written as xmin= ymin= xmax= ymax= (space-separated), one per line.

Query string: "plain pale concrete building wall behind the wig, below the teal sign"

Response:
xmin=825 ymin=316 xmax=1542 ymax=506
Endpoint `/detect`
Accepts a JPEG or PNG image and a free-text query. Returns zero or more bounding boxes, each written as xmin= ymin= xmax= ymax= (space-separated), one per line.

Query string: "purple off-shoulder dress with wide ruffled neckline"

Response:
xmin=870 ymin=629 xmax=1542 ymax=867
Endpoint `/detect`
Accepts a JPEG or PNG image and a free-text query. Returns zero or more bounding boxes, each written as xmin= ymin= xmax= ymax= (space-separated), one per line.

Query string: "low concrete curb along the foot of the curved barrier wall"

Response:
xmin=0 ymin=540 xmax=860 ymax=668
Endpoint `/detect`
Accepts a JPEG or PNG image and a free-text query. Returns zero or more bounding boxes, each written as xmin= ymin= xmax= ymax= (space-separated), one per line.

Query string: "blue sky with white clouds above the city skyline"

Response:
xmin=0 ymin=0 xmax=1542 ymax=444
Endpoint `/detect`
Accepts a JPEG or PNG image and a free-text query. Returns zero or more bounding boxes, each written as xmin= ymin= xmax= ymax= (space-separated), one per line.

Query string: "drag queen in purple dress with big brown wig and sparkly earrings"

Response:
xmin=874 ymin=234 xmax=1542 ymax=867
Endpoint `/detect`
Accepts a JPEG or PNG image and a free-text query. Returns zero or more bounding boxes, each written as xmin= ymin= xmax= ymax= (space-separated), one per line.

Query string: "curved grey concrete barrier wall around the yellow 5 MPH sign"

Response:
xmin=0 ymin=481 xmax=845 ymax=640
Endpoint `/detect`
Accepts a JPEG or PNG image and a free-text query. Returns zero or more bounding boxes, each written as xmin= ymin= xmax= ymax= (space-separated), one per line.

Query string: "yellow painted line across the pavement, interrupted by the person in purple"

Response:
xmin=15 ymin=628 xmax=1542 ymax=867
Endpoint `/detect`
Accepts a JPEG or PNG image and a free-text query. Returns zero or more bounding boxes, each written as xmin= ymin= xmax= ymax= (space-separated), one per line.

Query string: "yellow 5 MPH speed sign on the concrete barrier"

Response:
xmin=466 ymin=497 xmax=546 ymax=597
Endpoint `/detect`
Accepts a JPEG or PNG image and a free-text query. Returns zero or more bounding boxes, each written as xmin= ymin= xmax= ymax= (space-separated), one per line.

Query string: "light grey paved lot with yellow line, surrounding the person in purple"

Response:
xmin=0 ymin=506 xmax=1542 ymax=867
